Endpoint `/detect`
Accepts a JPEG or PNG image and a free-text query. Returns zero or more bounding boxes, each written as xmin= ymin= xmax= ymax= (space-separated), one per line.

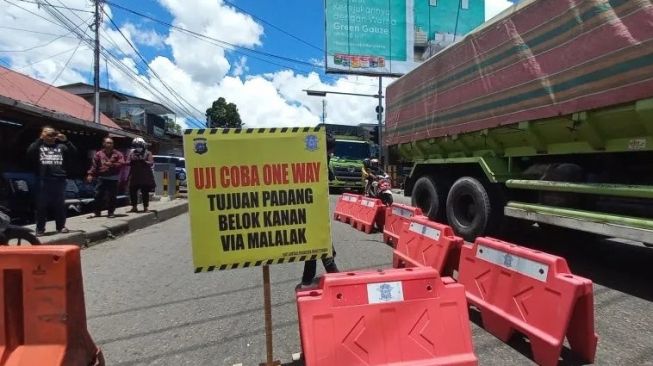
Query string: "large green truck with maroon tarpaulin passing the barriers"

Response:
xmin=384 ymin=0 xmax=653 ymax=244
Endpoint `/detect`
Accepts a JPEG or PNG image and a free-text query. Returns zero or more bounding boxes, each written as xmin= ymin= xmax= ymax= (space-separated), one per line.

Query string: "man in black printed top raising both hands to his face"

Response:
xmin=27 ymin=127 xmax=77 ymax=236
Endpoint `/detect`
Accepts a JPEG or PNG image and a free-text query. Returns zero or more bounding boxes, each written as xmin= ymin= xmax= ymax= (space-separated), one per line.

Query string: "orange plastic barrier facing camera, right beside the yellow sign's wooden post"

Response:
xmin=297 ymin=268 xmax=477 ymax=366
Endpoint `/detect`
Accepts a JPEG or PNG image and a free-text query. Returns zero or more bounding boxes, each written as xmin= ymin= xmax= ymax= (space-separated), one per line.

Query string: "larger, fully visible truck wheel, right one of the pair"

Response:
xmin=447 ymin=177 xmax=492 ymax=241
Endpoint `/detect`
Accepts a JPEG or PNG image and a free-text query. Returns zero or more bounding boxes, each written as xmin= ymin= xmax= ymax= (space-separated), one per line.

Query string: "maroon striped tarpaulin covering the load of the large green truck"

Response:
xmin=385 ymin=0 xmax=653 ymax=148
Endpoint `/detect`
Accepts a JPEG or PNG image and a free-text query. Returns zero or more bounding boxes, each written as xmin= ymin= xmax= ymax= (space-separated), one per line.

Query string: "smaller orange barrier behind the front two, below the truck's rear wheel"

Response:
xmin=392 ymin=216 xmax=464 ymax=276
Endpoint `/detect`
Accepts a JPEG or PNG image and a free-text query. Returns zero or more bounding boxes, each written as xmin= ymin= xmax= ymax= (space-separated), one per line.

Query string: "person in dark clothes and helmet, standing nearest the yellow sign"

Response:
xmin=127 ymin=137 xmax=156 ymax=212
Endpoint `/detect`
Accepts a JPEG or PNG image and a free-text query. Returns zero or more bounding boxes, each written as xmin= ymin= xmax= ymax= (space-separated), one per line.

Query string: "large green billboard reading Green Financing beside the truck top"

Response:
xmin=325 ymin=0 xmax=485 ymax=75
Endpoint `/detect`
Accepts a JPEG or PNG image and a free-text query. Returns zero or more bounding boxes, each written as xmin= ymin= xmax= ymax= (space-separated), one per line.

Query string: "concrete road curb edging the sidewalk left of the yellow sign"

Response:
xmin=40 ymin=200 xmax=188 ymax=247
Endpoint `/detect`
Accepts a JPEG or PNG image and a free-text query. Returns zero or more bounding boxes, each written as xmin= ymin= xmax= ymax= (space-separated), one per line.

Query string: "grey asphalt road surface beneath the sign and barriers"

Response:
xmin=82 ymin=196 xmax=653 ymax=366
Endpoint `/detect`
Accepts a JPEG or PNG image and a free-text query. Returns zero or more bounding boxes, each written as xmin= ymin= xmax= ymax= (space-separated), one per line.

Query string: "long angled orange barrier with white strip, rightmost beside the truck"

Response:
xmin=458 ymin=238 xmax=598 ymax=365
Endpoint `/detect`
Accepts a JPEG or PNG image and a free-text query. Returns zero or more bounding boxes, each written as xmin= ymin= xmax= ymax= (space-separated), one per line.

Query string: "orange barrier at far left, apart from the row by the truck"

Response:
xmin=0 ymin=245 xmax=104 ymax=366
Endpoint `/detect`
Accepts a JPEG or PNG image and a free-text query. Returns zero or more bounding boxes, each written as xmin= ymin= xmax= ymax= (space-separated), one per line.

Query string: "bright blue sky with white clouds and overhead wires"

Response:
xmin=0 ymin=0 xmax=510 ymax=127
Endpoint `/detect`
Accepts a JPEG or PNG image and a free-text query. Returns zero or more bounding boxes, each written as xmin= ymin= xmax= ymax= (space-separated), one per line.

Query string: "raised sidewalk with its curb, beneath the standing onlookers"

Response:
xmin=28 ymin=199 xmax=188 ymax=246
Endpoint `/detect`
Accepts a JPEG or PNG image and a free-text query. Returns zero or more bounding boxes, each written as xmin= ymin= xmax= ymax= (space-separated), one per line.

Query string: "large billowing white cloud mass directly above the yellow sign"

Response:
xmin=104 ymin=0 xmax=387 ymax=127
